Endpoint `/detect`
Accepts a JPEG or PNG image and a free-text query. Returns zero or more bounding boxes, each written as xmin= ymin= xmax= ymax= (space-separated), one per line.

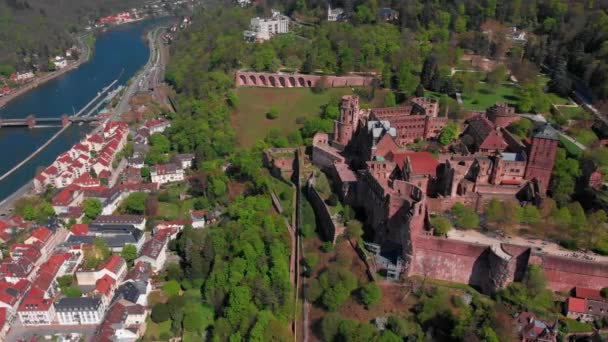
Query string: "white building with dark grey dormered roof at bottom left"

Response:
xmin=55 ymin=297 xmax=106 ymax=325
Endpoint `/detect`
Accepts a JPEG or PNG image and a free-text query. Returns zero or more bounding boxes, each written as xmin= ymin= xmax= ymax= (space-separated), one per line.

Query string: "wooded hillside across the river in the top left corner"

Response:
xmin=0 ymin=0 xmax=143 ymax=74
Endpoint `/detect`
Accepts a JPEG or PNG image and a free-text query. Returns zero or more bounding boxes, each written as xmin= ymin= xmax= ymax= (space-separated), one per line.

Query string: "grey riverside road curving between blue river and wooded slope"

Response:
xmin=114 ymin=27 xmax=166 ymax=116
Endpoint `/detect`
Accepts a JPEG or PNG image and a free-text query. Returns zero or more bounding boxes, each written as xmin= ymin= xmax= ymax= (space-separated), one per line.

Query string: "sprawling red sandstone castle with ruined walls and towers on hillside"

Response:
xmin=312 ymin=96 xmax=608 ymax=293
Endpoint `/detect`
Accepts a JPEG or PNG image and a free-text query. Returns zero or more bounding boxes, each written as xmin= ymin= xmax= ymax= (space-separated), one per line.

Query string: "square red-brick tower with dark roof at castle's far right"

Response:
xmin=524 ymin=124 xmax=559 ymax=191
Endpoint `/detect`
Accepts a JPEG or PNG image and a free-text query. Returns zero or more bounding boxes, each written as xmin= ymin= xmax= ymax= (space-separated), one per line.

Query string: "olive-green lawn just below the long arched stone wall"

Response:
xmin=232 ymin=87 xmax=385 ymax=147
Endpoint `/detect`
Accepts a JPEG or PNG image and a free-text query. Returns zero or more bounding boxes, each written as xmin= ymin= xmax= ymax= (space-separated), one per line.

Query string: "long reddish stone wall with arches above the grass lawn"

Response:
xmin=236 ymin=71 xmax=376 ymax=88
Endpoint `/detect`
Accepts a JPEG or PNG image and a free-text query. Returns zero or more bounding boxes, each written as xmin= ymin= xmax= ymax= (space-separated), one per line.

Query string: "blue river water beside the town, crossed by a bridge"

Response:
xmin=0 ymin=20 xmax=158 ymax=200
